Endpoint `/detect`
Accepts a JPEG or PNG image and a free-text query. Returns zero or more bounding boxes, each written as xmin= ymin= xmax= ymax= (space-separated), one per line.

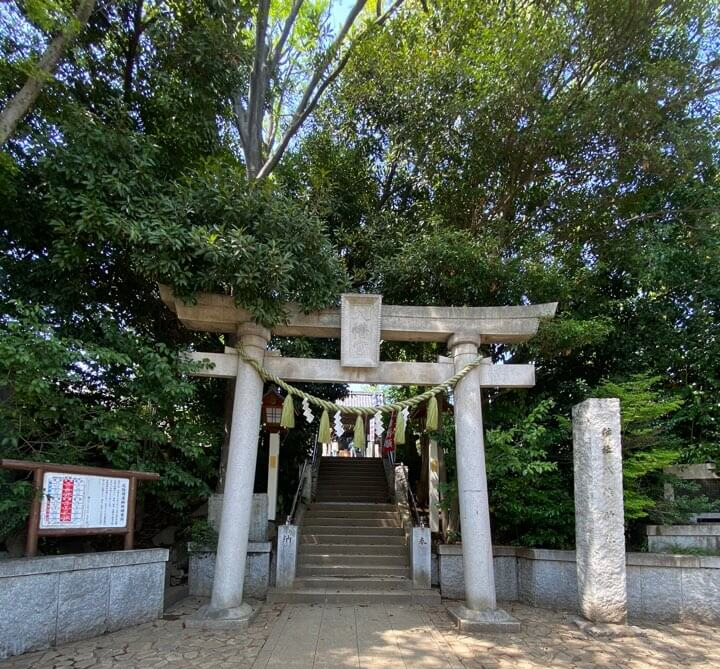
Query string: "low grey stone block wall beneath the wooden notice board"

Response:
xmin=0 ymin=548 xmax=168 ymax=659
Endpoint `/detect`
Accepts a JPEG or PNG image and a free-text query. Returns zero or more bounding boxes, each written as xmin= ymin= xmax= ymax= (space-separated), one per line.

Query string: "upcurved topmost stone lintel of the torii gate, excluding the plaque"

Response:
xmin=160 ymin=285 xmax=557 ymax=344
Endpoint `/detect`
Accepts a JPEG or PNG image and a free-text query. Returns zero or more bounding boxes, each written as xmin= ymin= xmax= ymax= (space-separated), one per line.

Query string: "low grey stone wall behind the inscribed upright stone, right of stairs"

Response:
xmin=437 ymin=544 xmax=720 ymax=622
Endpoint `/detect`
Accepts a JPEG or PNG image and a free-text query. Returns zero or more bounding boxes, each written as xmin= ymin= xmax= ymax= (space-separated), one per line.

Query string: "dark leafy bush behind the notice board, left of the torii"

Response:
xmin=0 ymin=303 xmax=218 ymax=531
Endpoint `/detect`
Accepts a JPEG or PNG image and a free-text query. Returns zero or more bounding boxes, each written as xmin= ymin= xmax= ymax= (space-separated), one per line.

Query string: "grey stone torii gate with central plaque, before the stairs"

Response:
xmin=160 ymin=286 xmax=557 ymax=627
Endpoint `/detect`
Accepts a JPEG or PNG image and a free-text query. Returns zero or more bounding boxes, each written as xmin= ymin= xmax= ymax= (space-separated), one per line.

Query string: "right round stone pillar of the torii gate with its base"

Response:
xmin=448 ymin=334 xmax=519 ymax=631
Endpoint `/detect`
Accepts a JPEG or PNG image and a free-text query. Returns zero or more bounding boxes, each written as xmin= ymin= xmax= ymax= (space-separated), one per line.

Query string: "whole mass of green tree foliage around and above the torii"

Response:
xmin=0 ymin=0 xmax=720 ymax=546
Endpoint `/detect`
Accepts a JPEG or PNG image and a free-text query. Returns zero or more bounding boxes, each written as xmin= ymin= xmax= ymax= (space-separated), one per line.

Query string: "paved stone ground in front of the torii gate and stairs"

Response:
xmin=0 ymin=599 xmax=720 ymax=669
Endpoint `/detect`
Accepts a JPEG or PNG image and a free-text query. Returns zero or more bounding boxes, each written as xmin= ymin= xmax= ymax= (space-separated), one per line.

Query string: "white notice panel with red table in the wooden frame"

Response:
xmin=40 ymin=472 xmax=130 ymax=530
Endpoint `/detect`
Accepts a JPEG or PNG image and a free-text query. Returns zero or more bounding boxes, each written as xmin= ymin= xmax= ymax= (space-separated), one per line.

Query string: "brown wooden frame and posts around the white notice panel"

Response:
xmin=0 ymin=459 xmax=160 ymax=557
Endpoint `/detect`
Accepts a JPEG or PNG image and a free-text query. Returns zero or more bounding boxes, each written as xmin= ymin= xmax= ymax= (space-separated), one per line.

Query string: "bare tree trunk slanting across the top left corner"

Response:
xmin=0 ymin=0 xmax=95 ymax=146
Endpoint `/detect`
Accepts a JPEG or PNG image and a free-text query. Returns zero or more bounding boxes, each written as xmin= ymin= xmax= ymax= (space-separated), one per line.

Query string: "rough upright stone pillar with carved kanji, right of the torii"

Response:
xmin=572 ymin=399 xmax=627 ymax=623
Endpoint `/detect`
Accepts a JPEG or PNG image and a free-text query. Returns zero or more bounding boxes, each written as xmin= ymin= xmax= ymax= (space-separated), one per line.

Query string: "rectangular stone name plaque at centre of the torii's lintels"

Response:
xmin=340 ymin=293 xmax=382 ymax=367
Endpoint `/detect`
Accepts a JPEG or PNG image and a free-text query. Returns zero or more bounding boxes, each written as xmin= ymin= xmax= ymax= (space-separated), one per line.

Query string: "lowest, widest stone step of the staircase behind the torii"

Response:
xmin=267 ymin=588 xmax=441 ymax=606
